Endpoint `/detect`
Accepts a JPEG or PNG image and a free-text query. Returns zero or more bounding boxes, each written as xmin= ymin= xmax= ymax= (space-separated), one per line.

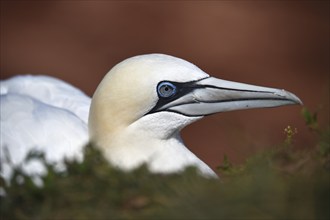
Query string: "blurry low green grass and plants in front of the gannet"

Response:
xmin=0 ymin=109 xmax=330 ymax=220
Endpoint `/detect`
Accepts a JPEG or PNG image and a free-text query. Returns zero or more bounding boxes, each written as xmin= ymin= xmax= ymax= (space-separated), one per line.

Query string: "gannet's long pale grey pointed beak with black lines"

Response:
xmin=154 ymin=77 xmax=302 ymax=116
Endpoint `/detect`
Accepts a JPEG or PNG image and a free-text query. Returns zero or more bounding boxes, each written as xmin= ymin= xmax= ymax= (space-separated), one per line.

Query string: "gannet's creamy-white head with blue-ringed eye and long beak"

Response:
xmin=89 ymin=54 xmax=301 ymax=158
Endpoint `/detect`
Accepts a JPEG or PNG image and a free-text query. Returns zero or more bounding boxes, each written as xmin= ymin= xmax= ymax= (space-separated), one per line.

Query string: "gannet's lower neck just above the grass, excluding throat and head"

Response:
xmin=101 ymin=129 xmax=216 ymax=176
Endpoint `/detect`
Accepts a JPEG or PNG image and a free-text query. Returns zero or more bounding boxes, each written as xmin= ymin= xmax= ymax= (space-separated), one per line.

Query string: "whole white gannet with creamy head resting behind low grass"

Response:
xmin=0 ymin=54 xmax=301 ymax=179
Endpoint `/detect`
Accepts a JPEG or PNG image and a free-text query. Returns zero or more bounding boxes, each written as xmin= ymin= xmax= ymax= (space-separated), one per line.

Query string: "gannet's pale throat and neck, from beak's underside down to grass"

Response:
xmin=89 ymin=100 xmax=214 ymax=176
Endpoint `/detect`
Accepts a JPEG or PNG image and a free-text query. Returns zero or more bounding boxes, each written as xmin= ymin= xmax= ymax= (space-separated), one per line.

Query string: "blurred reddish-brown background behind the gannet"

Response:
xmin=0 ymin=1 xmax=329 ymax=167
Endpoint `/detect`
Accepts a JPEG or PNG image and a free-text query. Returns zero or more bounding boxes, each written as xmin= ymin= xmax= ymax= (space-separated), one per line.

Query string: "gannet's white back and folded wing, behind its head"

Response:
xmin=0 ymin=76 xmax=91 ymax=179
